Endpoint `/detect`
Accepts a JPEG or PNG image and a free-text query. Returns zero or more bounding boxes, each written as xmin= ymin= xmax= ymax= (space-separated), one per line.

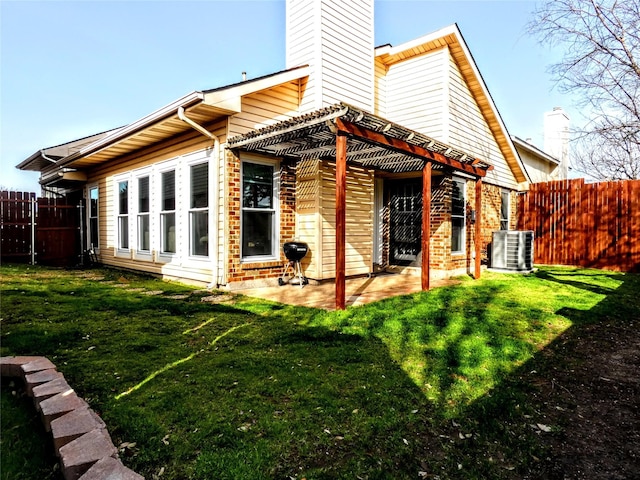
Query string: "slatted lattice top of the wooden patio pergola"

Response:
xmin=227 ymin=103 xmax=492 ymax=177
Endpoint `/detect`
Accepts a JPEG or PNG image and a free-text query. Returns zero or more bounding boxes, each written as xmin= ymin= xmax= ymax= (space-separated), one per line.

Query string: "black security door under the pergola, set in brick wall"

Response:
xmin=389 ymin=179 xmax=422 ymax=265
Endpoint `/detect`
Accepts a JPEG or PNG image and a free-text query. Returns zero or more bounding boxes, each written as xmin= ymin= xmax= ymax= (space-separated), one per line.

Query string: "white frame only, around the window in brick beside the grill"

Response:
xmin=240 ymin=155 xmax=280 ymax=263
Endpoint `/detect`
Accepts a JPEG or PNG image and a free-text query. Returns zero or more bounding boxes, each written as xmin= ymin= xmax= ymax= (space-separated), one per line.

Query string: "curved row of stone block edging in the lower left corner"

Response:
xmin=0 ymin=356 xmax=144 ymax=480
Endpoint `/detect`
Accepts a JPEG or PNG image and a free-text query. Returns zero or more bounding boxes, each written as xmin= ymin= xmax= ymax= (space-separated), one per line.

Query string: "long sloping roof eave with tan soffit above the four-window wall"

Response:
xmin=17 ymin=65 xmax=309 ymax=175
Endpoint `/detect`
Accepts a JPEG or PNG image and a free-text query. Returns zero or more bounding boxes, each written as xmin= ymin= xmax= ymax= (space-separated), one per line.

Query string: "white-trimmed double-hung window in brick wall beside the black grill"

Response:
xmin=241 ymin=160 xmax=279 ymax=261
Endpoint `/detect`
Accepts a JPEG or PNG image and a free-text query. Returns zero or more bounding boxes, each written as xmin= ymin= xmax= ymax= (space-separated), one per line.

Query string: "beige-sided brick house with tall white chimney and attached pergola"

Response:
xmin=18 ymin=0 xmax=530 ymax=304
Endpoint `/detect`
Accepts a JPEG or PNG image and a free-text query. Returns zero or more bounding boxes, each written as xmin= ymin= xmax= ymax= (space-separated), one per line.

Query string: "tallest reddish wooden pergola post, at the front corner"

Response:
xmin=336 ymin=134 xmax=347 ymax=310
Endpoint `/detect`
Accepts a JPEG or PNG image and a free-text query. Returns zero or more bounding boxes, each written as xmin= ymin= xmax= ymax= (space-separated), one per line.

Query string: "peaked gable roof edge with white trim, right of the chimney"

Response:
xmin=375 ymin=24 xmax=530 ymax=186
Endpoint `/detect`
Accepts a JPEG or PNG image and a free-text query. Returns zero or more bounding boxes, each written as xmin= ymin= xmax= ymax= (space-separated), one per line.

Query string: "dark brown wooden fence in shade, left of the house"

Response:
xmin=0 ymin=191 xmax=80 ymax=266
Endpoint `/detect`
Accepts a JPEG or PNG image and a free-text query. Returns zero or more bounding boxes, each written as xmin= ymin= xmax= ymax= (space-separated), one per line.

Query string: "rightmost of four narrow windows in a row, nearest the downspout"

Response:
xmin=189 ymin=163 xmax=209 ymax=257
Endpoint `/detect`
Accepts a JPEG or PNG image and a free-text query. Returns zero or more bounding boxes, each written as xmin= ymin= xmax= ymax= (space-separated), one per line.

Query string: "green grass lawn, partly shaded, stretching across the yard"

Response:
xmin=0 ymin=266 xmax=640 ymax=480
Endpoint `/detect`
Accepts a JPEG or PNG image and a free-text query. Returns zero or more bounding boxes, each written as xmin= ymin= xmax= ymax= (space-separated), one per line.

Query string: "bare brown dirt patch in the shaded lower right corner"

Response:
xmin=530 ymin=319 xmax=640 ymax=480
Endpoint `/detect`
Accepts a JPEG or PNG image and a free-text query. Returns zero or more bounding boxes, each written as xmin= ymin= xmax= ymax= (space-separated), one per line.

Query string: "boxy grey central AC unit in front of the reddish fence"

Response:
xmin=491 ymin=230 xmax=533 ymax=272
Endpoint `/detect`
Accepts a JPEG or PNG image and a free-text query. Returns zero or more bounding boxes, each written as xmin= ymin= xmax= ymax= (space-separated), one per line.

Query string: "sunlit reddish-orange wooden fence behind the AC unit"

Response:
xmin=518 ymin=179 xmax=640 ymax=272
